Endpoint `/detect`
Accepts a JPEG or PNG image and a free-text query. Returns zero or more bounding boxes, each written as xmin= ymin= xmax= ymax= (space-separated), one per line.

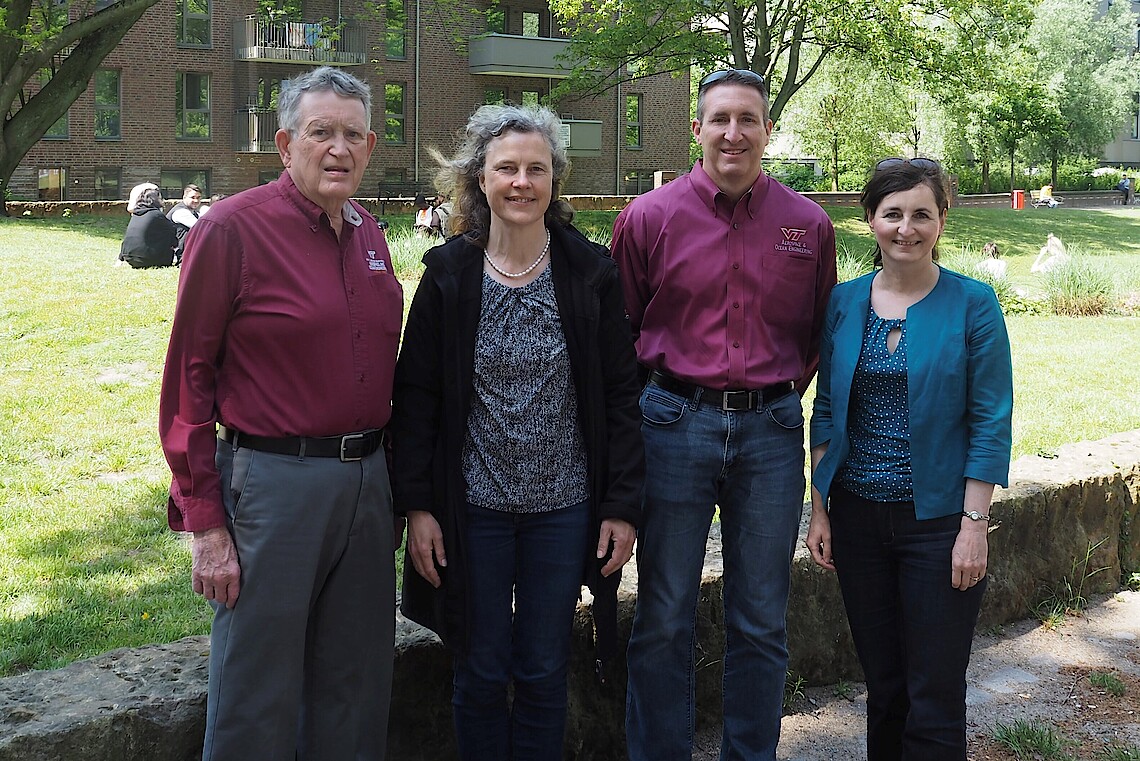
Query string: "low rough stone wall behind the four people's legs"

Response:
xmin=0 ymin=431 xmax=1140 ymax=761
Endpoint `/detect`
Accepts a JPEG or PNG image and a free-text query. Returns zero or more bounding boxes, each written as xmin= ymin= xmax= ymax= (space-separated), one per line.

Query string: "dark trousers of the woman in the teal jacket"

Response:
xmin=830 ymin=486 xmax=986 ymax=761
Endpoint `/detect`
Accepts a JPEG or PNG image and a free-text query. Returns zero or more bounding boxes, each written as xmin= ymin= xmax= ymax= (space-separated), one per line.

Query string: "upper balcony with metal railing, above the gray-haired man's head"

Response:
xmin=234 ymin=16 xmax=366 ymax=66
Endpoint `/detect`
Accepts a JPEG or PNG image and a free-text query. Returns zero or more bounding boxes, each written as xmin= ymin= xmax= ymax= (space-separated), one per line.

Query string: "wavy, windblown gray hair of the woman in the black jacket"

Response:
xmin=432 ymin=105 xmax=573 ymax=246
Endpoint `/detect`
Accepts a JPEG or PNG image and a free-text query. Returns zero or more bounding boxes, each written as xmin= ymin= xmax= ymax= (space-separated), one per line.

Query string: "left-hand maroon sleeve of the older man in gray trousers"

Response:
xmin=158 ymin=216 xmax=242 ymax=531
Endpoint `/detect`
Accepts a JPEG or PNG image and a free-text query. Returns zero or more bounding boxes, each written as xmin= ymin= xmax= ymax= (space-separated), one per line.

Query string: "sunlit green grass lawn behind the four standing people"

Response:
xmin=0 ymin=210 xmax=1140 ymax=676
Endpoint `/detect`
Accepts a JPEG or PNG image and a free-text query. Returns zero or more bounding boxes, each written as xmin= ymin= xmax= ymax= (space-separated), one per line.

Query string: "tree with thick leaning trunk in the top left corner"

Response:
xmin=0 ymin=0 xmax=158 ymax=216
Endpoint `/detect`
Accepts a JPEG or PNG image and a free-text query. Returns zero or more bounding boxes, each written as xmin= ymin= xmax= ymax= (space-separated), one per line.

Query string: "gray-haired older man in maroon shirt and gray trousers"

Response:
xmin=160 ymin=67 xmax=402 ymax=761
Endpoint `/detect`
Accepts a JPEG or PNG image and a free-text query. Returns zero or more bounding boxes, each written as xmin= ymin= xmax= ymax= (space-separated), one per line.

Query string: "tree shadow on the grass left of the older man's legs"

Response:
xmin=0 ymin=484 xmax=211 ymax=676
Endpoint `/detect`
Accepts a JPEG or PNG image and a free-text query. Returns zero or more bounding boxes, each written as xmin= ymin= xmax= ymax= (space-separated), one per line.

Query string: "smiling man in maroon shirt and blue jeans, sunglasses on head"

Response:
xmin=612 ymin=69 xmax=836 ymax=761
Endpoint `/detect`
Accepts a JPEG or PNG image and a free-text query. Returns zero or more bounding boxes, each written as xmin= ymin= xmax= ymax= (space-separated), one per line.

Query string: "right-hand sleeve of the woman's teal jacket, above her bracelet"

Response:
xmin=966 ymin=284 xmax=1013 ymax=486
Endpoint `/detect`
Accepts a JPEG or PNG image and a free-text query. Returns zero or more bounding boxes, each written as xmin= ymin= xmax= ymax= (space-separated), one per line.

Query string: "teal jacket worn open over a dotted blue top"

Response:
xmin=811 ymin=269 xmax=1013 ymax=521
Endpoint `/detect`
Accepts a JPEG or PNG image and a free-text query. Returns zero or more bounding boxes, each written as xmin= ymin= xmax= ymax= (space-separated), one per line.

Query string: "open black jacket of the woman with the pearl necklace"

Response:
xmin=391 ymin=226 xmax=645 ymax=662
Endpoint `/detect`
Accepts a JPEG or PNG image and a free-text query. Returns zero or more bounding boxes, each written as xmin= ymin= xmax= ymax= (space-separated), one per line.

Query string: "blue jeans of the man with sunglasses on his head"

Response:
xmin=626 ymin=384 xmax=804 ymax=761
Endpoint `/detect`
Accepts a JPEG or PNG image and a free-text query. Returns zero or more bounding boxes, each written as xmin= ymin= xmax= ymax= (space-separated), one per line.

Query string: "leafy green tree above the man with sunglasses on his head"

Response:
xmin=551 ymin=0 xmax=1031 ymax=120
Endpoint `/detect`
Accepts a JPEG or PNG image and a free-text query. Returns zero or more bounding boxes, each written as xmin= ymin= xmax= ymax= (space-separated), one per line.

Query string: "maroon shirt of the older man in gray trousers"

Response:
xmin=158 ymin=172 xmax=404 ymax=531
